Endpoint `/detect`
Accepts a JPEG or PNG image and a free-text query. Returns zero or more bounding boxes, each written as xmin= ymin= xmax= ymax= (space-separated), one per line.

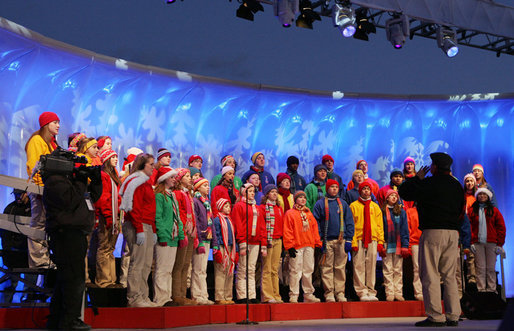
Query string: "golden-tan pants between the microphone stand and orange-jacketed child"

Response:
xmin=261 ymin=239 xmax=282 ymax=302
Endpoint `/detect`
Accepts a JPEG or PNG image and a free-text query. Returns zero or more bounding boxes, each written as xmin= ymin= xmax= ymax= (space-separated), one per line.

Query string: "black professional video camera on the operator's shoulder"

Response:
xmin=39 ymin=147 xmax=100 ymax=178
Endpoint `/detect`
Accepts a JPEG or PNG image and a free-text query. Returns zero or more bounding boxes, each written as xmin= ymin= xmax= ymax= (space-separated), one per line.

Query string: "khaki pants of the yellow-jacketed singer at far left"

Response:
xmin=27 ymin=193 xmax=52 ymax=268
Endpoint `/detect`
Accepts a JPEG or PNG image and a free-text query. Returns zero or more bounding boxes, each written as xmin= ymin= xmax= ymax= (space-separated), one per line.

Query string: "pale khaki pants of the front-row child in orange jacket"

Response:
xmin=289 ymin=247 xmax=314 ymax=298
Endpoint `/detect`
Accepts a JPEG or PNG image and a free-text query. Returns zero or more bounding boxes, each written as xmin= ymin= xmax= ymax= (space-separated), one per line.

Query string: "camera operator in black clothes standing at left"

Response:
xmin=43 ymin=150 xmax=102 ymax=330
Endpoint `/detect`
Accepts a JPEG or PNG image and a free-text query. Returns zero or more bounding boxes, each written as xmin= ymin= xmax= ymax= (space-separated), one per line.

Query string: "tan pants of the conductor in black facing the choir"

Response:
xmin=419 ymin=229 xmax=461 ymax=322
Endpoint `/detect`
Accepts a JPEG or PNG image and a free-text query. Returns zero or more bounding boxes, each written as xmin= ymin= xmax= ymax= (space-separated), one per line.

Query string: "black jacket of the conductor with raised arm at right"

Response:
xmin=398 ymin=175 xmax=465 ymax=231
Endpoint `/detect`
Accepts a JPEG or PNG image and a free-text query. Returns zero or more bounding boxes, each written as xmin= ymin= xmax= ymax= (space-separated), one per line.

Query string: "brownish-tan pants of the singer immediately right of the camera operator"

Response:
xmin=95 ymin=217 xmax=118 ymax=287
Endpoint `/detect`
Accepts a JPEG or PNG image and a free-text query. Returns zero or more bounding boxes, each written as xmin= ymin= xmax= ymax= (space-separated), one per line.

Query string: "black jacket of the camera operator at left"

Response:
xmin=43 ymin=174 xmax=102 ymax=233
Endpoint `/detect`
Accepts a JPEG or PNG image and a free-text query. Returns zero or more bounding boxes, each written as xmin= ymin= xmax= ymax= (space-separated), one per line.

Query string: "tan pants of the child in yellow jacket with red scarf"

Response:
xmin=352 ymin=240 xmax=377 ymax=298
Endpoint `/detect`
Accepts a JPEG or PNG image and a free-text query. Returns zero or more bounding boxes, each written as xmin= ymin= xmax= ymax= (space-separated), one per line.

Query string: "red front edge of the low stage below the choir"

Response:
xmin=0 ymin=301 xmax=424 ymax=329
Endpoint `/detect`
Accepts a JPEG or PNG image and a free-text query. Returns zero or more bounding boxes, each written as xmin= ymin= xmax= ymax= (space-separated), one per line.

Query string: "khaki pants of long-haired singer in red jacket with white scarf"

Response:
xmin=123 ymin=222 xmax=154 ymax=306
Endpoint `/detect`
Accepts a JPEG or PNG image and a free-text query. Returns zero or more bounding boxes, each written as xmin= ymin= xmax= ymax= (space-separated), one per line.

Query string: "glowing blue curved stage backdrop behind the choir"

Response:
xmin=0 ymin=19 xmax=514 ymax=296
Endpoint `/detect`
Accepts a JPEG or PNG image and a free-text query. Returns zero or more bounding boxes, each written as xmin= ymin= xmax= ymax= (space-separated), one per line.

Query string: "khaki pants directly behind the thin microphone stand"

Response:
xmin=236 ymin=245 xmax=260 ymax=300
